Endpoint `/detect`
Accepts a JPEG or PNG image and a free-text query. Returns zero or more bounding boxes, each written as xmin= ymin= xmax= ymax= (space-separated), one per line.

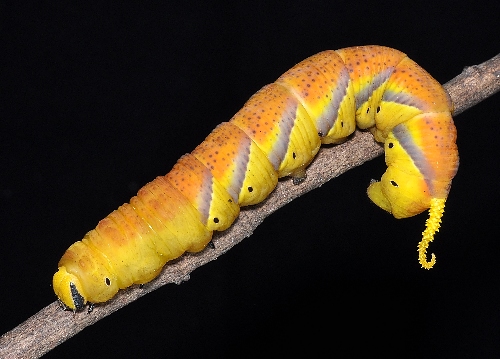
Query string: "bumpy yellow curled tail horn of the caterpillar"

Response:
xmin=418 ymin=198 xmax=446 ymax=269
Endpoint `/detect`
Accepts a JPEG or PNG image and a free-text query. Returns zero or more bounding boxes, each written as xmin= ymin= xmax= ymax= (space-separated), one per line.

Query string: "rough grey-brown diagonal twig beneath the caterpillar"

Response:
xmin=0 ymin=54 xmax=500 ymax=358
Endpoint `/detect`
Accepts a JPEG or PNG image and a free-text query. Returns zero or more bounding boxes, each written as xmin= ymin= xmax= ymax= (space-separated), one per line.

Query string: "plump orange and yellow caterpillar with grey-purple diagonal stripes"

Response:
xmin=53 ymin=45 xmax=459 ymax=311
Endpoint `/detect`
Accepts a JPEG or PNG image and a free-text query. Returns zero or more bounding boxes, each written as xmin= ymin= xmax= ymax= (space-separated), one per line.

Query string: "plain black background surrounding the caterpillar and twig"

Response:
xmin=0 ymin=1 xmax=500 ymax=358
